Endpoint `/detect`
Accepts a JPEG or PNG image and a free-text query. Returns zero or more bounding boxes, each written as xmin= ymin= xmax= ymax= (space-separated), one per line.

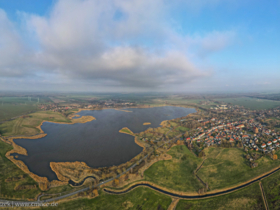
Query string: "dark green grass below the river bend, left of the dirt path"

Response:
xmin=34 ymin=187 xmax=171 ymax=210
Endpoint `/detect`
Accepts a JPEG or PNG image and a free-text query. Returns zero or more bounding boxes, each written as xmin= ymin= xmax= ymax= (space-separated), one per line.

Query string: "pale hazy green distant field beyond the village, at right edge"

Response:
xmin=215 ymin=97 xmax=280 ymax=109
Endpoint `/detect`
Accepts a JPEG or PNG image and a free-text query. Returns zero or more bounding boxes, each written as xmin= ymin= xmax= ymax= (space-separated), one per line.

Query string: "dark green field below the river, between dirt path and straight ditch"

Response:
xmin=176 ymin=183 xmax=265 ymax=210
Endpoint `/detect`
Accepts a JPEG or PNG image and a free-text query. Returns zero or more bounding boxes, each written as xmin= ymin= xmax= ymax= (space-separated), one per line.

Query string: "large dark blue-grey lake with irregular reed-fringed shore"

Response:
xmin=13 ymin=106 xmax=195 ymax=181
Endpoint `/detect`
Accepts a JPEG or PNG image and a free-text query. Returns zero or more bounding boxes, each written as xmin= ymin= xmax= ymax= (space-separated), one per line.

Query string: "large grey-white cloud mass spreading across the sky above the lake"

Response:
xmin=0 ymin=0 xmax=234 ymax=89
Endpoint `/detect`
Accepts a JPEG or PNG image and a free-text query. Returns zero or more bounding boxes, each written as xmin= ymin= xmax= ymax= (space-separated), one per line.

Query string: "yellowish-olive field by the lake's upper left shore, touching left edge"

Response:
xmin=0 ymin=111 xmax=71 ymax=136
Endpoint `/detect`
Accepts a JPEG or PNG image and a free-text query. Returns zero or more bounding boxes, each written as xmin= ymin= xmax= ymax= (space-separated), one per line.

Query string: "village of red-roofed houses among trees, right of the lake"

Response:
xmin=185 ymin=113 xmax=280 ymax=167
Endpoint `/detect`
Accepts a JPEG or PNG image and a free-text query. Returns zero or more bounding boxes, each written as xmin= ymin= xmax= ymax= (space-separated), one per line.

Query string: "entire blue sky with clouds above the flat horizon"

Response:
xmin=0 ymin=0 xmax=280 ymax=92
